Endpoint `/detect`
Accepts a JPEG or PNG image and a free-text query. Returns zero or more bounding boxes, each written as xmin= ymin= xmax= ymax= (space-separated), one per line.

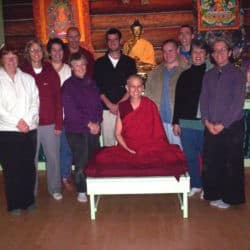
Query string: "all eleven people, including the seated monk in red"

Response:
xmin=0 ymin=22 xmax=245 ymax=215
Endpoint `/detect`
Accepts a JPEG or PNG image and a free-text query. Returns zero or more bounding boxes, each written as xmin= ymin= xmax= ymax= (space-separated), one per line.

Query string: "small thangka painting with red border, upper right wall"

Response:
xmin=197 ymin=0 xmax=240 ymax=31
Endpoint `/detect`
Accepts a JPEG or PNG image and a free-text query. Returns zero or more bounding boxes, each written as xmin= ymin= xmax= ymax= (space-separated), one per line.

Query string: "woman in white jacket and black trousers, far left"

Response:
xmin=0 ymin=46 xmax=39 ymax=215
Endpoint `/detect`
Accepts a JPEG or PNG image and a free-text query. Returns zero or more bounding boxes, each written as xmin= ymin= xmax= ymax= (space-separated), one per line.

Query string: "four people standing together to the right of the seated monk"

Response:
xmin=145 ymin=26 xmax=246 ymax=209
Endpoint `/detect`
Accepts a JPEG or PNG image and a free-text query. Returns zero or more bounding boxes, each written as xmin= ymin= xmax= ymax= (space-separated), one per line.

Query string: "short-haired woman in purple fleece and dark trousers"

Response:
xmin=62 ymin=53 xmax=102 ymax=202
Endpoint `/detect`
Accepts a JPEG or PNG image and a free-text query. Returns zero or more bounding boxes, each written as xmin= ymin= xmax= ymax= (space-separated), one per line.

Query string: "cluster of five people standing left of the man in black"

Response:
xmin=0 ymin=27 xmax=99 ymax=215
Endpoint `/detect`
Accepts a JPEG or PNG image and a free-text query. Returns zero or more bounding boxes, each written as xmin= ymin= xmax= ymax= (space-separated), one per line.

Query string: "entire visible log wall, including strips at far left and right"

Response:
xmin=3 ymin=0 xmax=250 ymax=62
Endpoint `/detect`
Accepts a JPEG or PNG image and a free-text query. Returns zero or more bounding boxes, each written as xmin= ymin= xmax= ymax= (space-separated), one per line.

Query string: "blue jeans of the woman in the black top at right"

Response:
xmin=181 ymin=128 xmax=204 ymax=188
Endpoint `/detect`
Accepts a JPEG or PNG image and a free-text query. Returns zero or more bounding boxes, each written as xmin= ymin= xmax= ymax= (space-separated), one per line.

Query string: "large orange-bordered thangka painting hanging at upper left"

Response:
xmin=33 ymin=0 xmax=93 ymax=51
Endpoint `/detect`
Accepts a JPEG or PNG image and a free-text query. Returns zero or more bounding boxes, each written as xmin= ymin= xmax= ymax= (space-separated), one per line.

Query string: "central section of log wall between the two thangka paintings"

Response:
xmin=90 ymin=0 xmax=193 ymax=62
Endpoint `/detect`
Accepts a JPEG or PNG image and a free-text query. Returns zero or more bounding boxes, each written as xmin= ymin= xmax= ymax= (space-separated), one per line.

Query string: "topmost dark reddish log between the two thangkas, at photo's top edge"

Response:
xmin=90 ymin=0 xmax=193 ymax=14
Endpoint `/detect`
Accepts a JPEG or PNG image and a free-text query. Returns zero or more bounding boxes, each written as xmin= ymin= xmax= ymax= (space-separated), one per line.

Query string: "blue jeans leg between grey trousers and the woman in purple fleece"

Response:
xmin=60 ymin=129 xmax=73 ymax=179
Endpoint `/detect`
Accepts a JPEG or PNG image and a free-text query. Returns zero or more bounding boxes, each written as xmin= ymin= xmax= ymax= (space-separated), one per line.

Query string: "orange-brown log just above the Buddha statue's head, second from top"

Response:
xmin=91 ymin=11 xmax=193 ymax=30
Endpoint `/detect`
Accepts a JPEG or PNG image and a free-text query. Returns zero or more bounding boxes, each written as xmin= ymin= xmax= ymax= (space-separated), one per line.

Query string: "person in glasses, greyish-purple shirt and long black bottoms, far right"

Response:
xmin=201 ymin=39 xmax=245 ymax=209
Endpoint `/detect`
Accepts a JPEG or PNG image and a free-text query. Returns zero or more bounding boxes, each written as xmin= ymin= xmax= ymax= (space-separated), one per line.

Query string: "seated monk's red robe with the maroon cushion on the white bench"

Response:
xmin=86 ymin=97 xmax=187 ymax=177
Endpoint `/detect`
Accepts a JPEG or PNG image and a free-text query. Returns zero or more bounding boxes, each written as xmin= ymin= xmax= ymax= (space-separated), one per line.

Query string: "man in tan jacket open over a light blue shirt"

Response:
xmin=145 ymin=39 xmax=187 ymax=146
